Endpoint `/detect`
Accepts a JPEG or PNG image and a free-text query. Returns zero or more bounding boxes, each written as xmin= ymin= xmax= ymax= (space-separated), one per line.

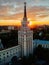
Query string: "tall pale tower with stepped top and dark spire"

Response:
xmin=18 ymin=2 xmax=33 ymax=56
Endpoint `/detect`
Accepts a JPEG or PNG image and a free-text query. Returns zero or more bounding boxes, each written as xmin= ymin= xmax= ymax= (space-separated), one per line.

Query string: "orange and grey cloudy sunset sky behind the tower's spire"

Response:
xmin=0 ymin=0 xmax=49 ymax=26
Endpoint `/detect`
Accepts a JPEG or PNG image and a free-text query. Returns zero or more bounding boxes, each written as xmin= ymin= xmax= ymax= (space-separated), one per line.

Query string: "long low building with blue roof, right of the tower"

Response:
xmin=33 ymin=39 xmax=49 ymax=48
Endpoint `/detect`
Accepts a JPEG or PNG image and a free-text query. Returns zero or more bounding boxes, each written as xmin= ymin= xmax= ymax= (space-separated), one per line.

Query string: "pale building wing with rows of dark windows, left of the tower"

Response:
xmin=0 ymin=45 xmax=21 ymax=65
